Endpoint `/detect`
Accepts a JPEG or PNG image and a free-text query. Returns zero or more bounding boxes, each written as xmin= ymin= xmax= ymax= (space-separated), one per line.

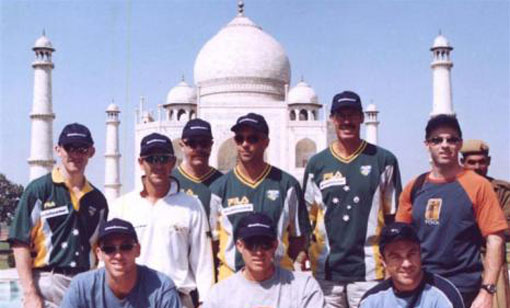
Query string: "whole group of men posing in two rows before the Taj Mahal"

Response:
xmin=9 ymin=91 xmax=510 ymax=308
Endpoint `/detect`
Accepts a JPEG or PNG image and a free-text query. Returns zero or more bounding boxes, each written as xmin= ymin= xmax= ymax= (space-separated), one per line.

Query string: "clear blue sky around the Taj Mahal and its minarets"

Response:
xmin=0 ymin=0 xmax=510 ymax=192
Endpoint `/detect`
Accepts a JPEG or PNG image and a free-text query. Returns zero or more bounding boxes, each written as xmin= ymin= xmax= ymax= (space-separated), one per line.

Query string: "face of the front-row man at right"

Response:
xmin=383 ymin=240 xmax=423 ymax=291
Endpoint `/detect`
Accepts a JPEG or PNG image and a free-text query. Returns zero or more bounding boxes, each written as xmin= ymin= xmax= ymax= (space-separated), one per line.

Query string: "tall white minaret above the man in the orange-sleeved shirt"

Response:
xmin=430 ymin=33 xmax=455 ymax=116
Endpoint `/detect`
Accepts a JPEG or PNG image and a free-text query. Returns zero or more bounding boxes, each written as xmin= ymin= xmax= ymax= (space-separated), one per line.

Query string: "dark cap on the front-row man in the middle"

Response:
xmin=234 ymin=213 xmax=276 ymax=241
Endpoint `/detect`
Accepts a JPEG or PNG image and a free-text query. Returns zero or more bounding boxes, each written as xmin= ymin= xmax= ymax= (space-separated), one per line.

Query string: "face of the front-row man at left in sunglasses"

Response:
xmin=96 ymin=235 xmax=140 ymax=280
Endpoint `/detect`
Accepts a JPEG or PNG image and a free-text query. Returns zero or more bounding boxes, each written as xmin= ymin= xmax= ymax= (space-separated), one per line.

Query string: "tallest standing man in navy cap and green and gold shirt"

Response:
xmin=303 ymin=91 xmax=401 ymax=307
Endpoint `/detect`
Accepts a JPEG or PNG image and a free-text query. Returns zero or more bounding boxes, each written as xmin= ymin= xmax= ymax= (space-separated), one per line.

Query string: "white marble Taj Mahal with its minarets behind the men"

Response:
xmin=24 ymin=2 xmax=454 ymax=205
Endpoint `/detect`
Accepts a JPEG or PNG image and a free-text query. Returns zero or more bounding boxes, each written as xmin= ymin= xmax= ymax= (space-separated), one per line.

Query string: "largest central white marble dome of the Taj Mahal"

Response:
xmin=194 ymin=14 xmax=290 ymax=98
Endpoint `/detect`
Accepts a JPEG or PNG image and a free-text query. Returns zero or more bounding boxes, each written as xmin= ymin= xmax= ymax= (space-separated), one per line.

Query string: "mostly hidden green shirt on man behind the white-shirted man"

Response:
xmin=172 ymin=166 xmax=223 ymax=217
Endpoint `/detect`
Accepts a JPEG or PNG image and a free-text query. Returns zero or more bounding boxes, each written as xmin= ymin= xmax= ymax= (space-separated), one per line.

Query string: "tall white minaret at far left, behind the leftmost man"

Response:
xmin=28 ymin=31 xmax=55 ymax=180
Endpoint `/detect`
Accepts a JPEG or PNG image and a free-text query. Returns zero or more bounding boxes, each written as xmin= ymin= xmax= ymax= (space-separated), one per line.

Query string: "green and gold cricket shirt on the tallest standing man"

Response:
xmin=303 ymin=141 xmax=402 ymax=282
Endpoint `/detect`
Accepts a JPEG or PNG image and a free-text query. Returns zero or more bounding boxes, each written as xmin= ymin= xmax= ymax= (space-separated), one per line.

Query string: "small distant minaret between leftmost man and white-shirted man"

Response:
xmin=104 ymin=103 xmax=121 ymax=204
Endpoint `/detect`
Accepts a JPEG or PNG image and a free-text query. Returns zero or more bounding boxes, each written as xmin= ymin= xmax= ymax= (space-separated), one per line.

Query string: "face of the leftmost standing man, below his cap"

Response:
xmin=55 ymin=144 xmax=95 ymax=176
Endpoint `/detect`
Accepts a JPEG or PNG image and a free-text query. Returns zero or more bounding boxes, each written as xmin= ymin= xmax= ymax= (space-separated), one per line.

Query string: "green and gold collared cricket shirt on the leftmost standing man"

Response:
xmin=9 ymin=168 xmax=108 ymax=271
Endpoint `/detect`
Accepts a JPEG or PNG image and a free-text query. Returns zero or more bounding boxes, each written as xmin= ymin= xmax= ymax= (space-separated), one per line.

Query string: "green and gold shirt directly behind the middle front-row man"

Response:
xmin=209 ymin=164 xmax=311 ymax=280
